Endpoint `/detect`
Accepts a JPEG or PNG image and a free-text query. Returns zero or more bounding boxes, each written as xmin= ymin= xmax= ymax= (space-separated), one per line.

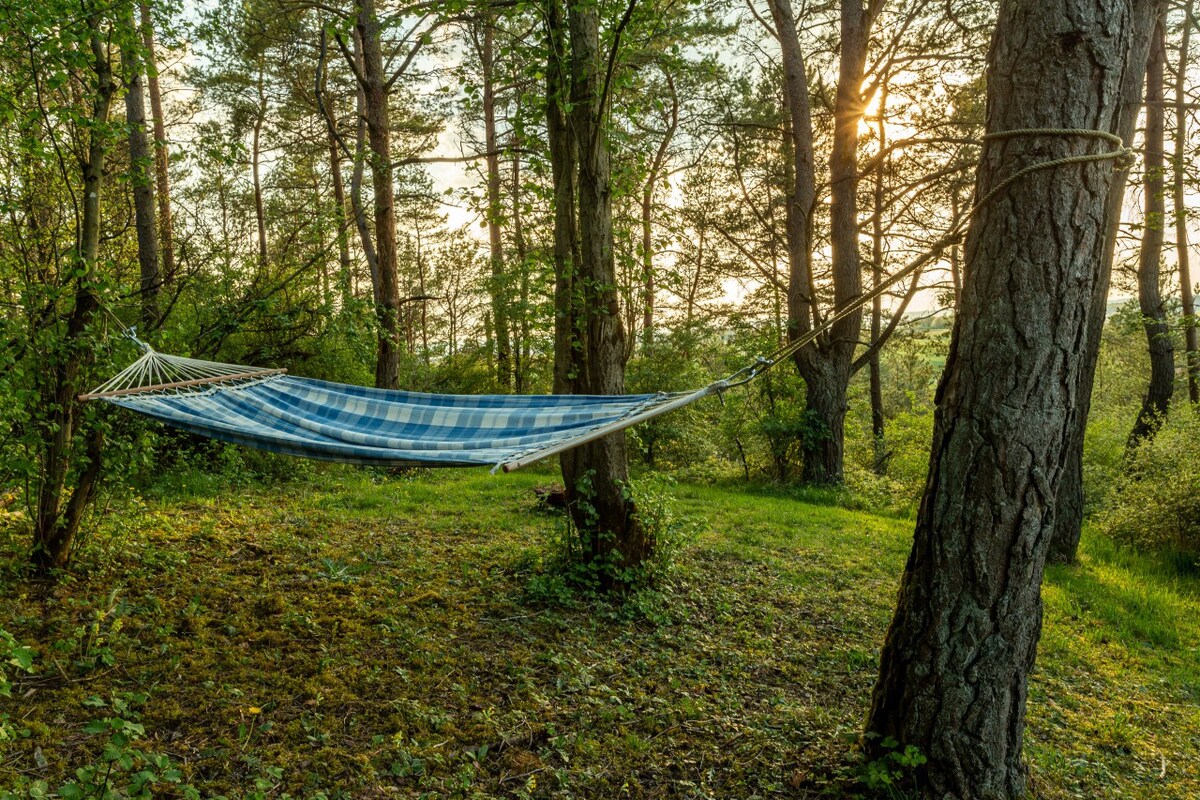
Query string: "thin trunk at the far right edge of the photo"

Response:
xmin=1171 ymin=0 xmax=1200 ymax=405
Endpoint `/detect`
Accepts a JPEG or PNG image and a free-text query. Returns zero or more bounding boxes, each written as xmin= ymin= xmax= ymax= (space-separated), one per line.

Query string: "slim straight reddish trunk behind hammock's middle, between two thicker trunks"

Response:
xmin=479 ymin=13 xmax=512 ymax=391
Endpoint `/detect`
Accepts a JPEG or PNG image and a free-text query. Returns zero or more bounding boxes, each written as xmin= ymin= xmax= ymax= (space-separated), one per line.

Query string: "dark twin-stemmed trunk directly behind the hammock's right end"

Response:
xmin=546 ymin=0 xmax=654 ymax=589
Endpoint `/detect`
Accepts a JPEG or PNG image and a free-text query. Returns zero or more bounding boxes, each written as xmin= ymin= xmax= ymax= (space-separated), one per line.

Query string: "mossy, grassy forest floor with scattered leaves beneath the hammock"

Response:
xmin=0 ymin=469 xmax=1200 ymax=800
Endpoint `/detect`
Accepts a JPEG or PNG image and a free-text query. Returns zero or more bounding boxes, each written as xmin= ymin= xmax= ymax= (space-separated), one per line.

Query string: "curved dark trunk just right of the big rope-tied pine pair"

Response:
xmin=1129 ymin=20 xmax=1175 ymax=450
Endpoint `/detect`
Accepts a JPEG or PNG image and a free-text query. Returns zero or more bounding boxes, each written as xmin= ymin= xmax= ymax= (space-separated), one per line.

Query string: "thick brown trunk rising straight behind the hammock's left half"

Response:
xmin=355 ymin=0 xmax=400 ymax=389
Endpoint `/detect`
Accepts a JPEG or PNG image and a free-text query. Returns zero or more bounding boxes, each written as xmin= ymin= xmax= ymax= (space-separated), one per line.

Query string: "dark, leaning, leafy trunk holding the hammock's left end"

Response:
xmin=31 ymin=13 xmax=116 ymax=573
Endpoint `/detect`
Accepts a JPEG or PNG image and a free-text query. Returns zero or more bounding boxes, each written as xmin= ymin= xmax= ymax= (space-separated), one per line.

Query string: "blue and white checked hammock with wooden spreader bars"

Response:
xmin=82 ymin=348 xmax=725 ymax=471
